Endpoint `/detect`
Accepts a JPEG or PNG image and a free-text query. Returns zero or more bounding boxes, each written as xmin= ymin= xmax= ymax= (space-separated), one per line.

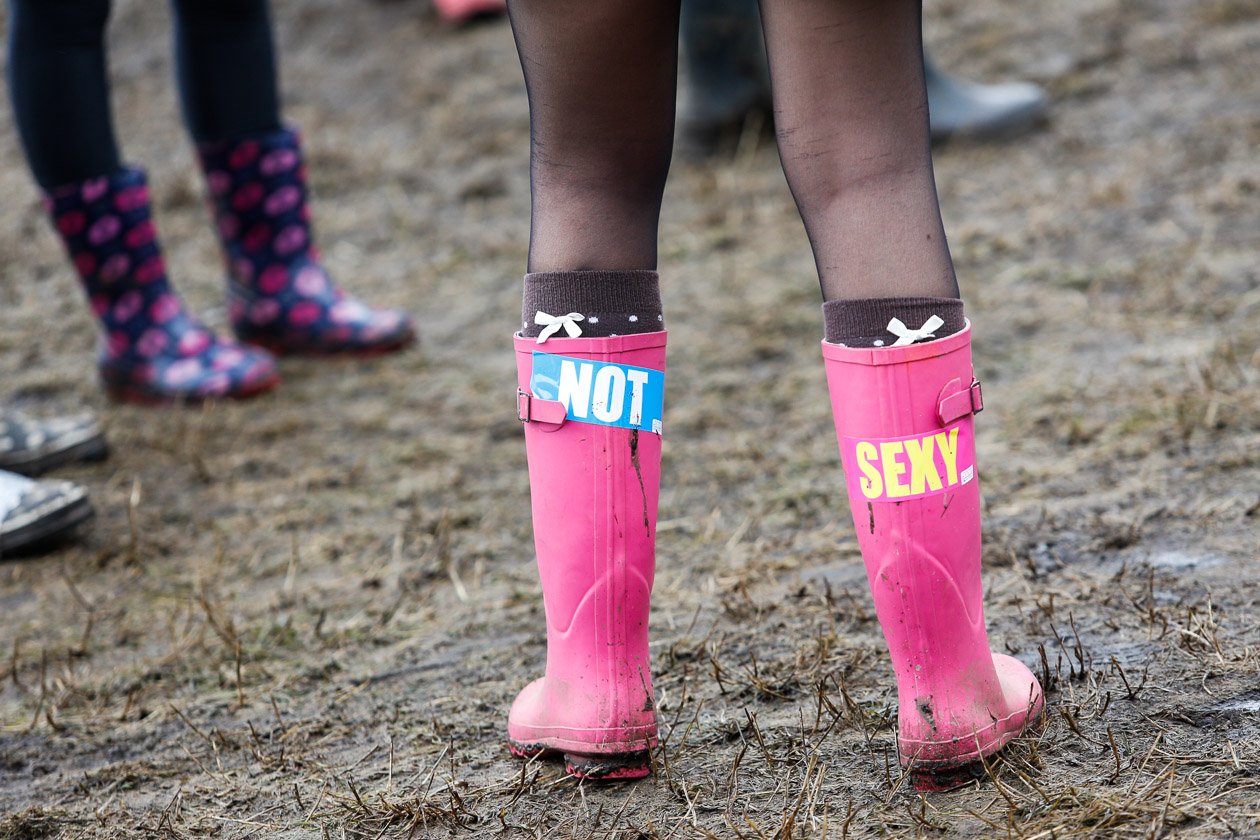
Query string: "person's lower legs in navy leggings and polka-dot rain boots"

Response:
xmin=9 ymin=0 xmax=413 ymax=403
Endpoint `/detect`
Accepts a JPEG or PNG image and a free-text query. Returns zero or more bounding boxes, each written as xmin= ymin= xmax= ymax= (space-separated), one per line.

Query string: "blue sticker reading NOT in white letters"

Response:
xmin=529 ymin=351 xmax=665 ymax=434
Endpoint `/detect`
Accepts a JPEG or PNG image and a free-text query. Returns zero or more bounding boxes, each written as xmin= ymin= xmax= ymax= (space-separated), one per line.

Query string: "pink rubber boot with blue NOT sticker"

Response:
xmin=508 ymin=331 xmax=665 ymax=780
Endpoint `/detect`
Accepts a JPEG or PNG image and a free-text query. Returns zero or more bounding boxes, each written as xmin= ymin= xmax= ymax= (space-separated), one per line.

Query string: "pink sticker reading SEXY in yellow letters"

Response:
xmin=840 ymin=418 xmax=975 ymax=501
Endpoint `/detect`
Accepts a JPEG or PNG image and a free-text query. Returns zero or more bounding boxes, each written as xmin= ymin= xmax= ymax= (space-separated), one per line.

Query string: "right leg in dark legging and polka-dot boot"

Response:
xmin=174 ymin=0 xmax=415 ymax=355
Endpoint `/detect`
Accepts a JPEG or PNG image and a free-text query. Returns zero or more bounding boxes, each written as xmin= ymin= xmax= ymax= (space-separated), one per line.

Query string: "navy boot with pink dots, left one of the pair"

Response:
xmin=44 ymin=169 xmax=280 ymax=403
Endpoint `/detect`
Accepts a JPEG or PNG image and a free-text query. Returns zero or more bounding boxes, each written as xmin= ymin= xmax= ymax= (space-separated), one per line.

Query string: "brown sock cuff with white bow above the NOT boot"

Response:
xmin=520 ymin=271 xmax=665 ymax=339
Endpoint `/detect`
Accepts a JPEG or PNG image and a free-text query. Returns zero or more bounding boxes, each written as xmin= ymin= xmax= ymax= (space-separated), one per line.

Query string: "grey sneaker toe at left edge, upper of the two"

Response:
xmin=0 ymin=409 xmax=108 ymax=476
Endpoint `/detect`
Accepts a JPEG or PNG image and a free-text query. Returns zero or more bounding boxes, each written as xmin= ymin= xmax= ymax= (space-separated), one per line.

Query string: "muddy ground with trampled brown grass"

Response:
xmin=0 ymin=0 xmax=1260 ymax=840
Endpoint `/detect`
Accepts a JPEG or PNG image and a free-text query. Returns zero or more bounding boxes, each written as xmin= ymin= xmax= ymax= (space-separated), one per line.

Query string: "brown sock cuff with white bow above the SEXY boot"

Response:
xmin=823 ymin=297 xmax=966 ymax=348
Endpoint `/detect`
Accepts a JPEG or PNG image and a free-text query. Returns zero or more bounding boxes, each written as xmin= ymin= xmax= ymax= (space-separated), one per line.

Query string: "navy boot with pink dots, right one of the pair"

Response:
xmin=199 ymin=128 xmax=416 ymax=355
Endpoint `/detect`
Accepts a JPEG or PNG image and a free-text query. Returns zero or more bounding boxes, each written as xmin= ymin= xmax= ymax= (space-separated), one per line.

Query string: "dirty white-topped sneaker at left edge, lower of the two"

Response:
xmin=0 ymin=472 xmax=96 ymax=559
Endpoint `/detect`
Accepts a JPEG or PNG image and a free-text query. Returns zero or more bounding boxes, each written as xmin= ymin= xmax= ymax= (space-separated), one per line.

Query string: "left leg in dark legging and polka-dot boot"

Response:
xmin=8 ymin=0 xmax=278 ymax=403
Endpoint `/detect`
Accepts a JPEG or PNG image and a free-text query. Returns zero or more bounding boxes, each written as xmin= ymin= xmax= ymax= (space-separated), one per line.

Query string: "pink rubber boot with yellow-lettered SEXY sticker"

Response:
xmin=823 ymin=325 xmax=1043 ymax=787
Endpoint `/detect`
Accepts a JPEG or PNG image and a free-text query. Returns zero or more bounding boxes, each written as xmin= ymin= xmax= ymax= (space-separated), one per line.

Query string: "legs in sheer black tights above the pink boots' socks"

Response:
xmin=508 ymin=0 xmax=958 ymax=301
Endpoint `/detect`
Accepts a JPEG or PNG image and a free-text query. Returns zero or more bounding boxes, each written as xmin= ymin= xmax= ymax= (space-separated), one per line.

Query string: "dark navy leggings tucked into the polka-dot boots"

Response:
xmin=9 ymin=0 xmax=280 ymax=189
